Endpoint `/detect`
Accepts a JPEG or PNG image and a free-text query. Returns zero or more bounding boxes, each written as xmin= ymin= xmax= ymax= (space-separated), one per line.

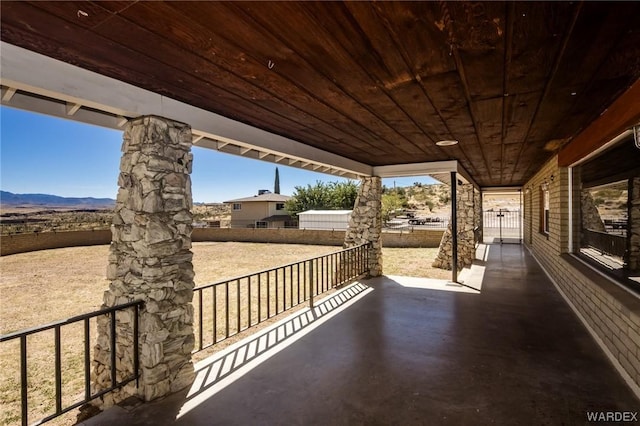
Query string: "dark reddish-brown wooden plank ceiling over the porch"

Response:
xmin=0 ymin=0 xmax=640 ymax=186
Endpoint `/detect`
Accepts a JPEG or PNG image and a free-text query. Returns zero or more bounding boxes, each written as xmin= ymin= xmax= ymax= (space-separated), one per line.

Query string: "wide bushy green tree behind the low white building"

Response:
xmin=285 ymin=181 xmax=358 ymax=216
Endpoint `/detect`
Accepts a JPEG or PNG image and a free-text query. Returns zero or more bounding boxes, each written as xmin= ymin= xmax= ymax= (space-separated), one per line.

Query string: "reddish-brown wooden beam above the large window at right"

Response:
xmin=558 ymin=79 xmax=640 ymax=167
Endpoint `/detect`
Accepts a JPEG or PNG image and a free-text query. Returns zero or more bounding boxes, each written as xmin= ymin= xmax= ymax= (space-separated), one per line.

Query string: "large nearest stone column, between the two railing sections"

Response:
xmin=92 ymin=116 xmax=194 ymax=408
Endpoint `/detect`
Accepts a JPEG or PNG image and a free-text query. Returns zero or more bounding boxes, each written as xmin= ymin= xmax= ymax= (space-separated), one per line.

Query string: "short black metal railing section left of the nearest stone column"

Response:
xmin=0 ymin=301 xmax=143 ymax=425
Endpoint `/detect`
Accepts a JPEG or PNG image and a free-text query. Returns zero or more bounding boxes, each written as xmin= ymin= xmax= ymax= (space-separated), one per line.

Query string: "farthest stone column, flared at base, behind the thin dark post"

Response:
xmin=433 ymin=183 xmax=476 ymax=270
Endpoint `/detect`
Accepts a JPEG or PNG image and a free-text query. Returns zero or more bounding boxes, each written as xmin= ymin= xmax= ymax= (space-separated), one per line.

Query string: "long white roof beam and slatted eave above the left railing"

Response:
xmin=0 ymin=42 xmax=373 ymax=178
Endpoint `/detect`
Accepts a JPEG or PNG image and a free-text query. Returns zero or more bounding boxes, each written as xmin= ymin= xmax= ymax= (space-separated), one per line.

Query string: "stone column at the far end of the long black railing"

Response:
xmin=344 ymin=176 xmax=382 ymax=277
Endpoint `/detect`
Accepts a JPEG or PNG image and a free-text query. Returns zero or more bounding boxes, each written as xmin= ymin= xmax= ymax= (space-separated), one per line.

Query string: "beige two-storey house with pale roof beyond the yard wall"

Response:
xmin=224 ymin=189 xmax=295 ymax=228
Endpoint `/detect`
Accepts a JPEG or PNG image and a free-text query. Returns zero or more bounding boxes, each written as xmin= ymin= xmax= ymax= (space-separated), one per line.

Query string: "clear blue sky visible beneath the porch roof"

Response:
xmin=0 ymin=107 xmax=433 ymax=202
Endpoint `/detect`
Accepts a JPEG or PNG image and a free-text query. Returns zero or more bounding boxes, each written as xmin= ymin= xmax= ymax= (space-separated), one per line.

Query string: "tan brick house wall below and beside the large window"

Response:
xmin=525 ymin=156 xmax=640 ymax=395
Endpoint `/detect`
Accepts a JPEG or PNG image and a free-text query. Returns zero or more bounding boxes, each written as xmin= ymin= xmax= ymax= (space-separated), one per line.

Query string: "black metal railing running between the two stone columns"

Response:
xmin=193 ymin=244 xmax=370 ymax=352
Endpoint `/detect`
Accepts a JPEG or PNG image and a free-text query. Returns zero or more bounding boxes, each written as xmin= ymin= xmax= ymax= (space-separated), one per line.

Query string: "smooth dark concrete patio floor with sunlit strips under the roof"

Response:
xmin=83 ymin=245 xmax=640 ymax=426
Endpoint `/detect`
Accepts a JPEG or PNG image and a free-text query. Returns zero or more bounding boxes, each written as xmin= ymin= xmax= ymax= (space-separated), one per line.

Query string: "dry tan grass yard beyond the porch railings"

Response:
xmin=0 ymin=242 xmax=450 ymax=425
